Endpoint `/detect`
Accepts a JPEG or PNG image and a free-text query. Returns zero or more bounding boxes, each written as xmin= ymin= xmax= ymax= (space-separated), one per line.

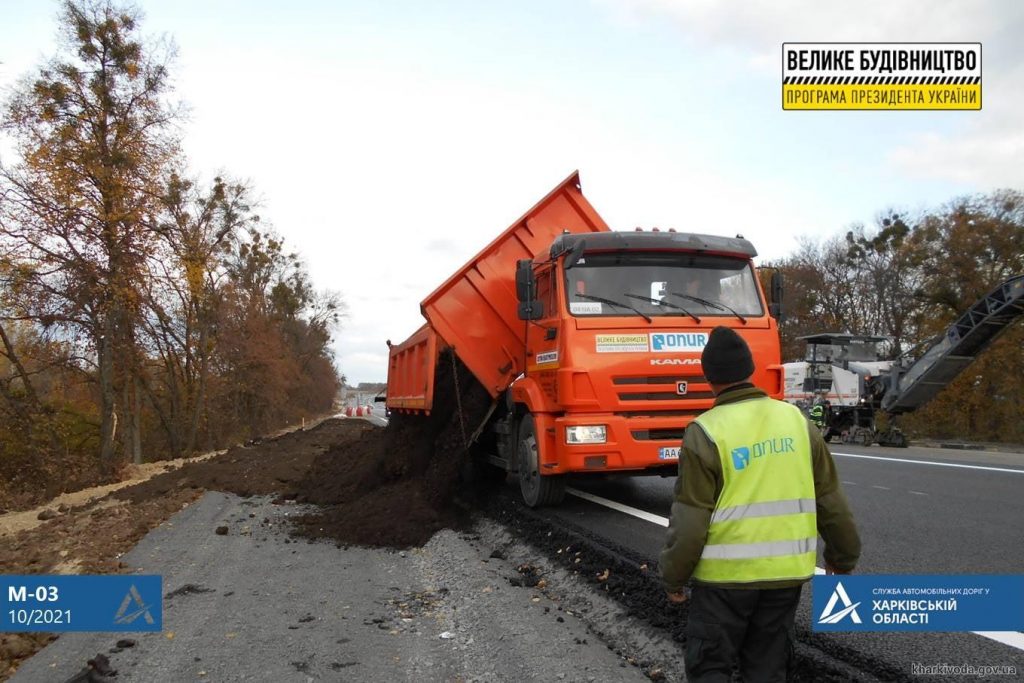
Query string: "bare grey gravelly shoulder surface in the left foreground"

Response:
xmin=11 ymin=493 xmax=655 ymax=683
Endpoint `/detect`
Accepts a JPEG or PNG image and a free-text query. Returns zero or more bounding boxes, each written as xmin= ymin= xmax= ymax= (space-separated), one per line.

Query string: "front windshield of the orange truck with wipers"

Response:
xmin=565 ymin=252 xmax=764 ymax=317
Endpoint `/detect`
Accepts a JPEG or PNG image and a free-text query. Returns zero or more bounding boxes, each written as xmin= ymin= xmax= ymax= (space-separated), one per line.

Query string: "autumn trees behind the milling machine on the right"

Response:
xmin=774 ymin=190 xmax=1024 ymax=443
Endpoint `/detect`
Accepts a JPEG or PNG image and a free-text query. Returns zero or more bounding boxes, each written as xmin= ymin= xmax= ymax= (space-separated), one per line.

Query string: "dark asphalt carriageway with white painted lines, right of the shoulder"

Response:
xmin=545 ymin=444 xmax=1024 ymax=680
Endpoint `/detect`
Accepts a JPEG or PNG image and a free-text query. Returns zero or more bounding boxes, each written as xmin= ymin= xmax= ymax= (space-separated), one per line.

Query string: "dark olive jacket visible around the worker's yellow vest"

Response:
xmin=660 ymin=384 xmax=860 ymax=593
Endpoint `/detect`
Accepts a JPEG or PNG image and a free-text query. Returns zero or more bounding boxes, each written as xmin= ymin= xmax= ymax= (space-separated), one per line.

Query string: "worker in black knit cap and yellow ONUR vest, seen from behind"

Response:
xmin=659 ymin=327 xmax=860 ymax=683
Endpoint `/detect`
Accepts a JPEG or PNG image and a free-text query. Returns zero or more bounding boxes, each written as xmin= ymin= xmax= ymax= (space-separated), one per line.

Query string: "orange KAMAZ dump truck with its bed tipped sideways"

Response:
xmin=386 ymin=173 xmax=782 ymax=506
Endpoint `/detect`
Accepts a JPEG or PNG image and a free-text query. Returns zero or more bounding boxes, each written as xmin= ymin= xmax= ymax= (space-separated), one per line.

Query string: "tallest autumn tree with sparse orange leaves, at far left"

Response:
xmin=0 ymin=1 xmax=177 ymax=468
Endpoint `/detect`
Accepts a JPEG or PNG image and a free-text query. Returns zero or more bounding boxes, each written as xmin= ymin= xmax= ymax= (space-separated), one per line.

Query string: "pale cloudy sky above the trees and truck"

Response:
xmin=0 ymin=0 xmax=1024 ymax=384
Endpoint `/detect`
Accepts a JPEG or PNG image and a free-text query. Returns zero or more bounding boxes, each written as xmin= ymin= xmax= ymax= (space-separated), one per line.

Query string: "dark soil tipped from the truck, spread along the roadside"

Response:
xmin=114 ymin=351 xmax=492 ymax=548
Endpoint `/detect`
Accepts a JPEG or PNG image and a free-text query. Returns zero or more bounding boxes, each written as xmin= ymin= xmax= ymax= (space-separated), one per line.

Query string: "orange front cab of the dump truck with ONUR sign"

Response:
xmin=510 ymin=231 xmax=782 ymax=498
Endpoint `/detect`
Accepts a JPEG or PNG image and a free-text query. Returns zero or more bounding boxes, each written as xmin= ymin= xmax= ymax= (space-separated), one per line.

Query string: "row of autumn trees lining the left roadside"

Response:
xmin=0 ymin=0 xmax=343 ymax=507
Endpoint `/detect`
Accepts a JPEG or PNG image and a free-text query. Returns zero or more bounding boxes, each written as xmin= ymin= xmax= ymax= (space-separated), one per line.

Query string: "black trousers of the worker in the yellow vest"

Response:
xmin=686 ymin=585 xmax=801 ymax=683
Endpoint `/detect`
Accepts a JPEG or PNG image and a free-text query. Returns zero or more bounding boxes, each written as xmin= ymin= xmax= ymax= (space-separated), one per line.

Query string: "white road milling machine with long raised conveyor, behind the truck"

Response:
xmin=784 ymin=275 xmax=1024 ymax=447
